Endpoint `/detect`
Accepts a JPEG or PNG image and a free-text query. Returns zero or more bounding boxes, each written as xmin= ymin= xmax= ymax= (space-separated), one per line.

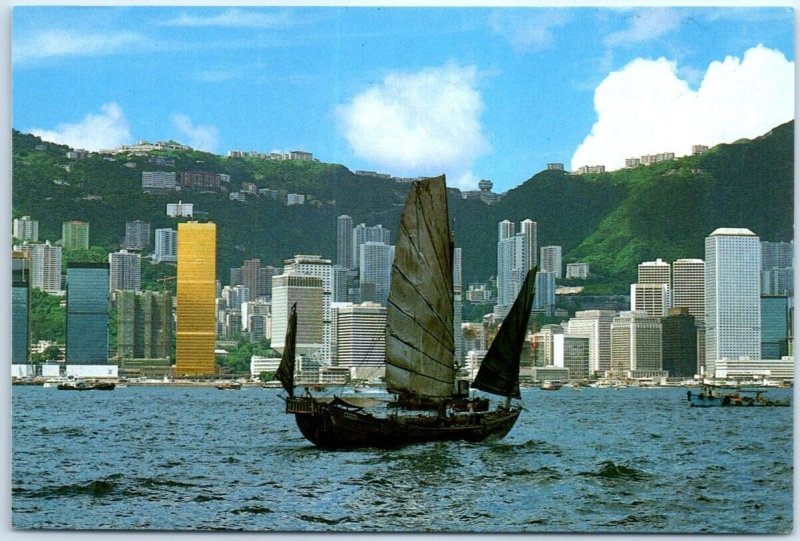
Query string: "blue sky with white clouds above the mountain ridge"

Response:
xmin=12 ymin=3 xmax=794 ymax=192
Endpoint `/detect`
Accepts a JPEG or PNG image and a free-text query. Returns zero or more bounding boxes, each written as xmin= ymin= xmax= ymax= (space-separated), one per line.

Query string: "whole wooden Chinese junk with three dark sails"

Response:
xmin=276 ymin=176 xmax=536 ymax=448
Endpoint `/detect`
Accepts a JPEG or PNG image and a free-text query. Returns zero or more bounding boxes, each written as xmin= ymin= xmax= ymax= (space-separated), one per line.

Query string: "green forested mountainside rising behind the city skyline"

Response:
xmin=12 ymin=122 xmax=794 ymax=293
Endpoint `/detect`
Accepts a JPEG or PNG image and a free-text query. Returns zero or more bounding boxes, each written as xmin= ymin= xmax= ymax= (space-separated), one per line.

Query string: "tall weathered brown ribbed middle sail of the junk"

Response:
xmin=386 ymin=176 xmax=455 ymax=401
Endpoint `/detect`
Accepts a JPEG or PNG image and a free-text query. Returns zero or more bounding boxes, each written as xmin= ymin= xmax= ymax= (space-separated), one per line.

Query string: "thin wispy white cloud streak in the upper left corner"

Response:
xmin=11 ymin=30 xmax=149 ymax=63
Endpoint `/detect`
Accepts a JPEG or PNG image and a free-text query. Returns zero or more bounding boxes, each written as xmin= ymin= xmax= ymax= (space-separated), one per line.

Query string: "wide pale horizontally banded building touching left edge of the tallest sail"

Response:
xmin=336 ymin=302 xmax=386 ymax=368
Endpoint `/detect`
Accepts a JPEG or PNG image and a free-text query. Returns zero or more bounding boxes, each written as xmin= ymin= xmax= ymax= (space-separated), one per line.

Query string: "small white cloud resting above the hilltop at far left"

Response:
xmin=28 ymin=102 xmax=131 ymax=150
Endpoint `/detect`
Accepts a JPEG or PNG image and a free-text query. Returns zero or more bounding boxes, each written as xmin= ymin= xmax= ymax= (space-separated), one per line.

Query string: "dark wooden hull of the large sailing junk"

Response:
xmin=286 ymin=397 xmax=521 ymax=449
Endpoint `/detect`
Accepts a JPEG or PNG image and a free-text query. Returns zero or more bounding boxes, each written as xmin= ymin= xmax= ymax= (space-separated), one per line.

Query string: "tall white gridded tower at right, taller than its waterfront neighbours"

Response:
xmin=705 ymin=228 xmax=761 ymax=362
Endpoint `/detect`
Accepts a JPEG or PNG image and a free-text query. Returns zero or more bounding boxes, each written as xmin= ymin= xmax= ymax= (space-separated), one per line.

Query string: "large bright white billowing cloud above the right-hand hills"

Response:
xmin=572 ymin=45 xmax=794 ymax=170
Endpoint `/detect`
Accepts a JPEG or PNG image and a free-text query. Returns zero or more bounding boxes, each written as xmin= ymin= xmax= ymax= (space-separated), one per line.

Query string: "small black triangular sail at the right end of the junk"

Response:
xmin=472 ymin=267 xmax=536 ymax=398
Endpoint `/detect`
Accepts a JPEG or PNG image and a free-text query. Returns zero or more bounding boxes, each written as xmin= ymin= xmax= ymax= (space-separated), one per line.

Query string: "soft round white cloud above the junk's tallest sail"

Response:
xmin=335 ymin=65 xmax=489 ymax=188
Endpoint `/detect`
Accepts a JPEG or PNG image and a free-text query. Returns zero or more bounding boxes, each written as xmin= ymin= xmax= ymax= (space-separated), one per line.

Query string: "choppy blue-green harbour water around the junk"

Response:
xmin=12 ymin=386 xmax=793 ymax=533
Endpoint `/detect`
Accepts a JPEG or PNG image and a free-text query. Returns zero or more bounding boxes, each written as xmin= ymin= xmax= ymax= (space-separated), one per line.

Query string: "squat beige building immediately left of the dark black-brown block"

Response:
xmin=611 ymin=312 xmax=662 ymax=378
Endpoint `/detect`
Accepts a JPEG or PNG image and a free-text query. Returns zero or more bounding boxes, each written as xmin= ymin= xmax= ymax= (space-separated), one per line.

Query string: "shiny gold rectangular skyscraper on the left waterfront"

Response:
xmin=175 ymin=222 xmax=217 ymax=377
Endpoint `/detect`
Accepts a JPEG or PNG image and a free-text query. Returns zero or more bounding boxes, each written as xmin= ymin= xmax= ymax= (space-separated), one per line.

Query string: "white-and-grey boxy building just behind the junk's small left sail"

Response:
xmin=271 ymin=272 xmax=324 ymax=355
